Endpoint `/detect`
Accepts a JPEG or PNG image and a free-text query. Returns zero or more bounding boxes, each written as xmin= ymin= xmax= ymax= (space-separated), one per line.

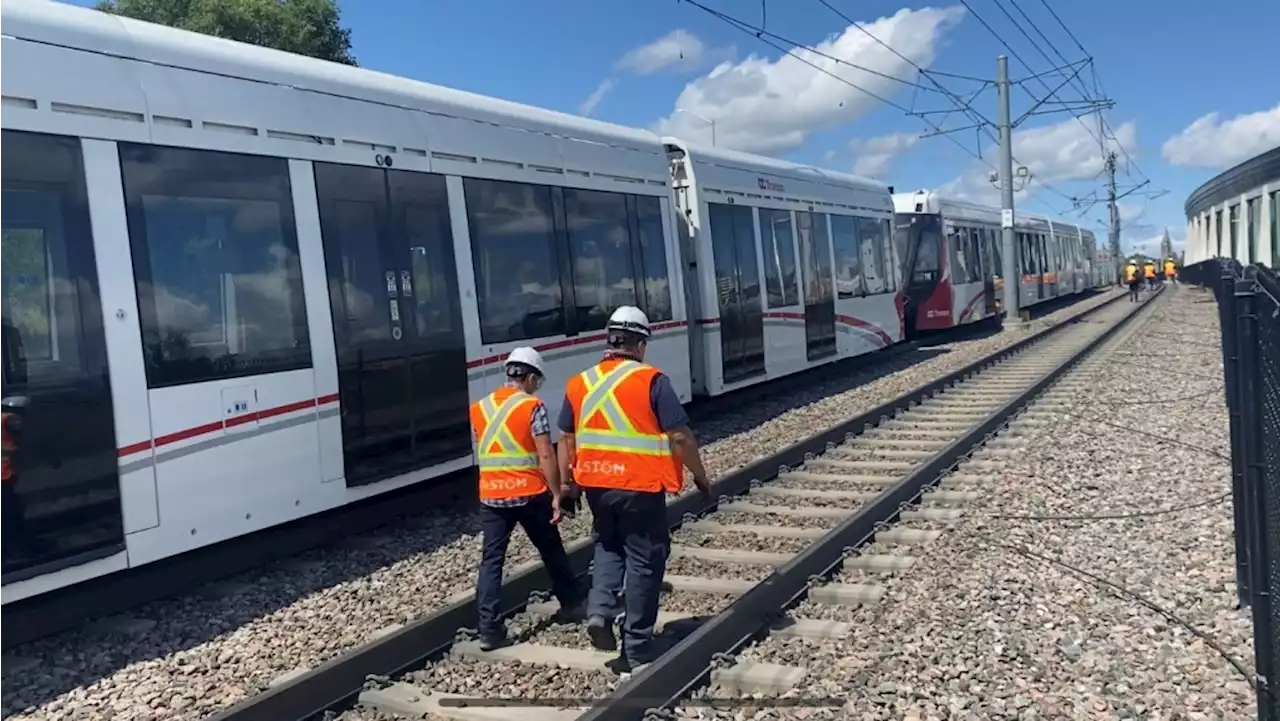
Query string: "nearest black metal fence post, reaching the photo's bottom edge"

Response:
xmin=1231 ymin=278 xmax=1280 ymax=721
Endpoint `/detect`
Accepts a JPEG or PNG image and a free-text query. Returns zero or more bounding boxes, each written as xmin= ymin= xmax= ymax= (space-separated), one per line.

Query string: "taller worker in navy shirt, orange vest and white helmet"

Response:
xmin=558 ymin=306 xmax=712 ymax=674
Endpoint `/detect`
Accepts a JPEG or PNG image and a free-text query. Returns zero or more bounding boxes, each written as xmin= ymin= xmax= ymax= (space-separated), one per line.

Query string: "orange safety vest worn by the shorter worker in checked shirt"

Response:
xmin=471 ymin=385 xmax=547 ymax=501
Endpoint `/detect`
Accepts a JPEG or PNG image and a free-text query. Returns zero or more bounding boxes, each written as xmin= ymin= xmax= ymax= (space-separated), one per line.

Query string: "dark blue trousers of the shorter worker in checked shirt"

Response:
xmin=476 ymin=493 xmax=580 ymax=634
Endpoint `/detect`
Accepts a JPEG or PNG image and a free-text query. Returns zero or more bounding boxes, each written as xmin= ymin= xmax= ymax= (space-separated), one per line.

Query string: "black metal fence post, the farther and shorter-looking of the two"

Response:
xmin=1206 ymin=263 xmax=1253 ymax=608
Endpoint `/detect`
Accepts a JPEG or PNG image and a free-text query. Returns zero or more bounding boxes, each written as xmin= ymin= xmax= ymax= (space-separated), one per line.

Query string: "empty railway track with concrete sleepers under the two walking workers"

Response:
xmin=204 ymin=286 xmax=1157 ymax=721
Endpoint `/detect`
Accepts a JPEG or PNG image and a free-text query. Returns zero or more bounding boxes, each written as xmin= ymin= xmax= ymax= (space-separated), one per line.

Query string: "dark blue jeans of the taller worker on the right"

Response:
xmin=584 ymin=488 xmax=671 ymax=660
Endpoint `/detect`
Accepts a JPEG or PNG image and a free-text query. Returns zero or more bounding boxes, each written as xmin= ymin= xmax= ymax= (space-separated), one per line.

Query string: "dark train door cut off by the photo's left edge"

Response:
xmin=0 ymin=131 xmax=123 ymax=584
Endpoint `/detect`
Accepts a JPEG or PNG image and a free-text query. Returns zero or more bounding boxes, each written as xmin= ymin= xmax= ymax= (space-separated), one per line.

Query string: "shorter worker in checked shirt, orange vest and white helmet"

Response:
xmin=471 ymin=347 xmax=582 ymax=651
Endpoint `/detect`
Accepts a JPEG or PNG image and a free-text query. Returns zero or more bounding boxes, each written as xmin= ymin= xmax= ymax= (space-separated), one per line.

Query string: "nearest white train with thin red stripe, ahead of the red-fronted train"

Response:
xmin=0 ymin=1 xmax=902 ymax=603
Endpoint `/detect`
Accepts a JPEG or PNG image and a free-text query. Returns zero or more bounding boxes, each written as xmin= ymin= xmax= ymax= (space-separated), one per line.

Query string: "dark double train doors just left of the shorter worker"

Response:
xmin=315 ymin=163 xmax=471 ymax=485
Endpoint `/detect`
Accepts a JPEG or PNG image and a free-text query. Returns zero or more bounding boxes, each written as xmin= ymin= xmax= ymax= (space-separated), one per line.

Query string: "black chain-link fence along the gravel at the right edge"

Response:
xmin=1180 ymin=259 xmax=1280 ymax=721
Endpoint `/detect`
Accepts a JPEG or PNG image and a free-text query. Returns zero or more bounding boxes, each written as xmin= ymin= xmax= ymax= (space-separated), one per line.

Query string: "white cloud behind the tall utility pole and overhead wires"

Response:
xmin=941 ymin=118 xmax=1138 ymax=207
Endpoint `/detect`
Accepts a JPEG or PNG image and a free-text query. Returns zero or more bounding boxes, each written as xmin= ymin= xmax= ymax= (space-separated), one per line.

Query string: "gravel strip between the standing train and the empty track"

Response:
xmin=0 ymin=291 xmax=1117 ymax=721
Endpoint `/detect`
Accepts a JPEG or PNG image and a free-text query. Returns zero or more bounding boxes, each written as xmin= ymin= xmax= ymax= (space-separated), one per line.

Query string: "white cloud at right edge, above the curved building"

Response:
xmin=1161 ymin=105 xmax=1280 ymax=168
